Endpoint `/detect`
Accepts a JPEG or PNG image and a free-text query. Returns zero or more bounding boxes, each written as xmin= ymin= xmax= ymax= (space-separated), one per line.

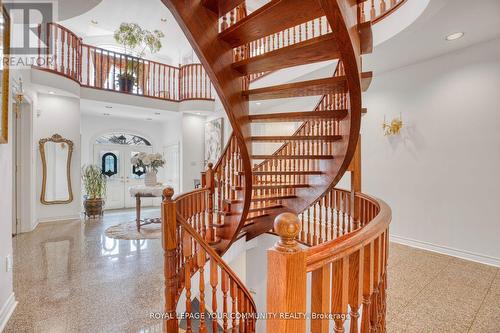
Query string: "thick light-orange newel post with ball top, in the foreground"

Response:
xmin=267 ymin=213 xmax=307 ymax=333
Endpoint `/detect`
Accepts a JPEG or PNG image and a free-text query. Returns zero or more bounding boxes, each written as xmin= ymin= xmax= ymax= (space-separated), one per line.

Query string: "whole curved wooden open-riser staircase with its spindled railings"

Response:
xmin=163 ymin=0 xmax=390 ymax=332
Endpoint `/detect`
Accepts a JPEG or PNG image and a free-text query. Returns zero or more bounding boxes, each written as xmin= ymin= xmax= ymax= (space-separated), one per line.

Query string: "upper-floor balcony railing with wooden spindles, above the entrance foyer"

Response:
xmin=36 ymin=23 xmax=214 ymax=102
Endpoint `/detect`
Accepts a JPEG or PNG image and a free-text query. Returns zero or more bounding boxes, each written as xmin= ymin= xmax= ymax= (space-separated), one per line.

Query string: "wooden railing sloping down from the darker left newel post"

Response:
xmin=162 ymin=188 xmax=257 ymax=333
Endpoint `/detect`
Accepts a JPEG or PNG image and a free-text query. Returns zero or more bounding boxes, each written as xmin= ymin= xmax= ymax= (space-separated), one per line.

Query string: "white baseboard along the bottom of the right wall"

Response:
xmin=390 ymin=235 xmax=500 ymax=267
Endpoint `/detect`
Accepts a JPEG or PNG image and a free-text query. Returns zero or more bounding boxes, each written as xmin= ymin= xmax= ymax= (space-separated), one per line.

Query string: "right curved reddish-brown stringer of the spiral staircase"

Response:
xmin=245 ymin=0 xmax=371 ymax=240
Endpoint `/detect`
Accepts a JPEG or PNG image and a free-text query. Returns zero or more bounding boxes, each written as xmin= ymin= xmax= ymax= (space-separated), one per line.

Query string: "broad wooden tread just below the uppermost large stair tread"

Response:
xmin=232 ymin=33 xmax=340 ymax=75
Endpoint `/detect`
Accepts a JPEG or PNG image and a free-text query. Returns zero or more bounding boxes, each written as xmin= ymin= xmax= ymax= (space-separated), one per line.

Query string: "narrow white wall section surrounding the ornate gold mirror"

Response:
xmin=34 ymin=94 xmax=81 ymax=222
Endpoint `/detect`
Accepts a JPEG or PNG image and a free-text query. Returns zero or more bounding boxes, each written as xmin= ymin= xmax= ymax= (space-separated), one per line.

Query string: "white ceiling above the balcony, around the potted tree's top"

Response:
xmin=61 ymin=0 xmax=192 ymax=65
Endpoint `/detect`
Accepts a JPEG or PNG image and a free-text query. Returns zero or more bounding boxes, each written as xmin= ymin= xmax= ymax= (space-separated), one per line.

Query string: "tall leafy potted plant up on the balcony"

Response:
xmin=114 ymin=23 xmax=165 ymax=92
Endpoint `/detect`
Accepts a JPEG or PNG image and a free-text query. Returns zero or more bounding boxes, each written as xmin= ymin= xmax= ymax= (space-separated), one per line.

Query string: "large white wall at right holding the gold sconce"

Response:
xmin=362 ymin=40 xmax=500 ymax=265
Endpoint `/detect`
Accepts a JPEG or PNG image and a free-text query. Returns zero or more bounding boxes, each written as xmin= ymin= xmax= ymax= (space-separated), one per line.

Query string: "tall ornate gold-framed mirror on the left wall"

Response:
xmin=39 ymin=134 xmax=73 ymax=205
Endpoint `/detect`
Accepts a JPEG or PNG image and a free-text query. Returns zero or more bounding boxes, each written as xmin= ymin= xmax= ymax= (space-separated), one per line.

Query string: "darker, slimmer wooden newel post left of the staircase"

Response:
xmin=161 ymin=187 xmax=178 ymax=333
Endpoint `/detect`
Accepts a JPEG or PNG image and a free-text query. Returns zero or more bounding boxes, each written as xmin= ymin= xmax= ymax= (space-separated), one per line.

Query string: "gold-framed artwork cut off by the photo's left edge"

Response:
xmin=0 ymin=0 xmax=10 ymax=143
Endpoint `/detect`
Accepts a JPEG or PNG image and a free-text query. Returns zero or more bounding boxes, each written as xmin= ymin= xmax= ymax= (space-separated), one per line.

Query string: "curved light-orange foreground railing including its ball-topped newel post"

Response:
xmin=267 ymin=190 xmax=391 ymax=333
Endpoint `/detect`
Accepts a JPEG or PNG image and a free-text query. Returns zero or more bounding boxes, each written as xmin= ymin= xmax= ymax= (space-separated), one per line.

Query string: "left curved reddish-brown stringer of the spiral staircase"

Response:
xmin=162 ymin=0 xmax=252 ymax=253
